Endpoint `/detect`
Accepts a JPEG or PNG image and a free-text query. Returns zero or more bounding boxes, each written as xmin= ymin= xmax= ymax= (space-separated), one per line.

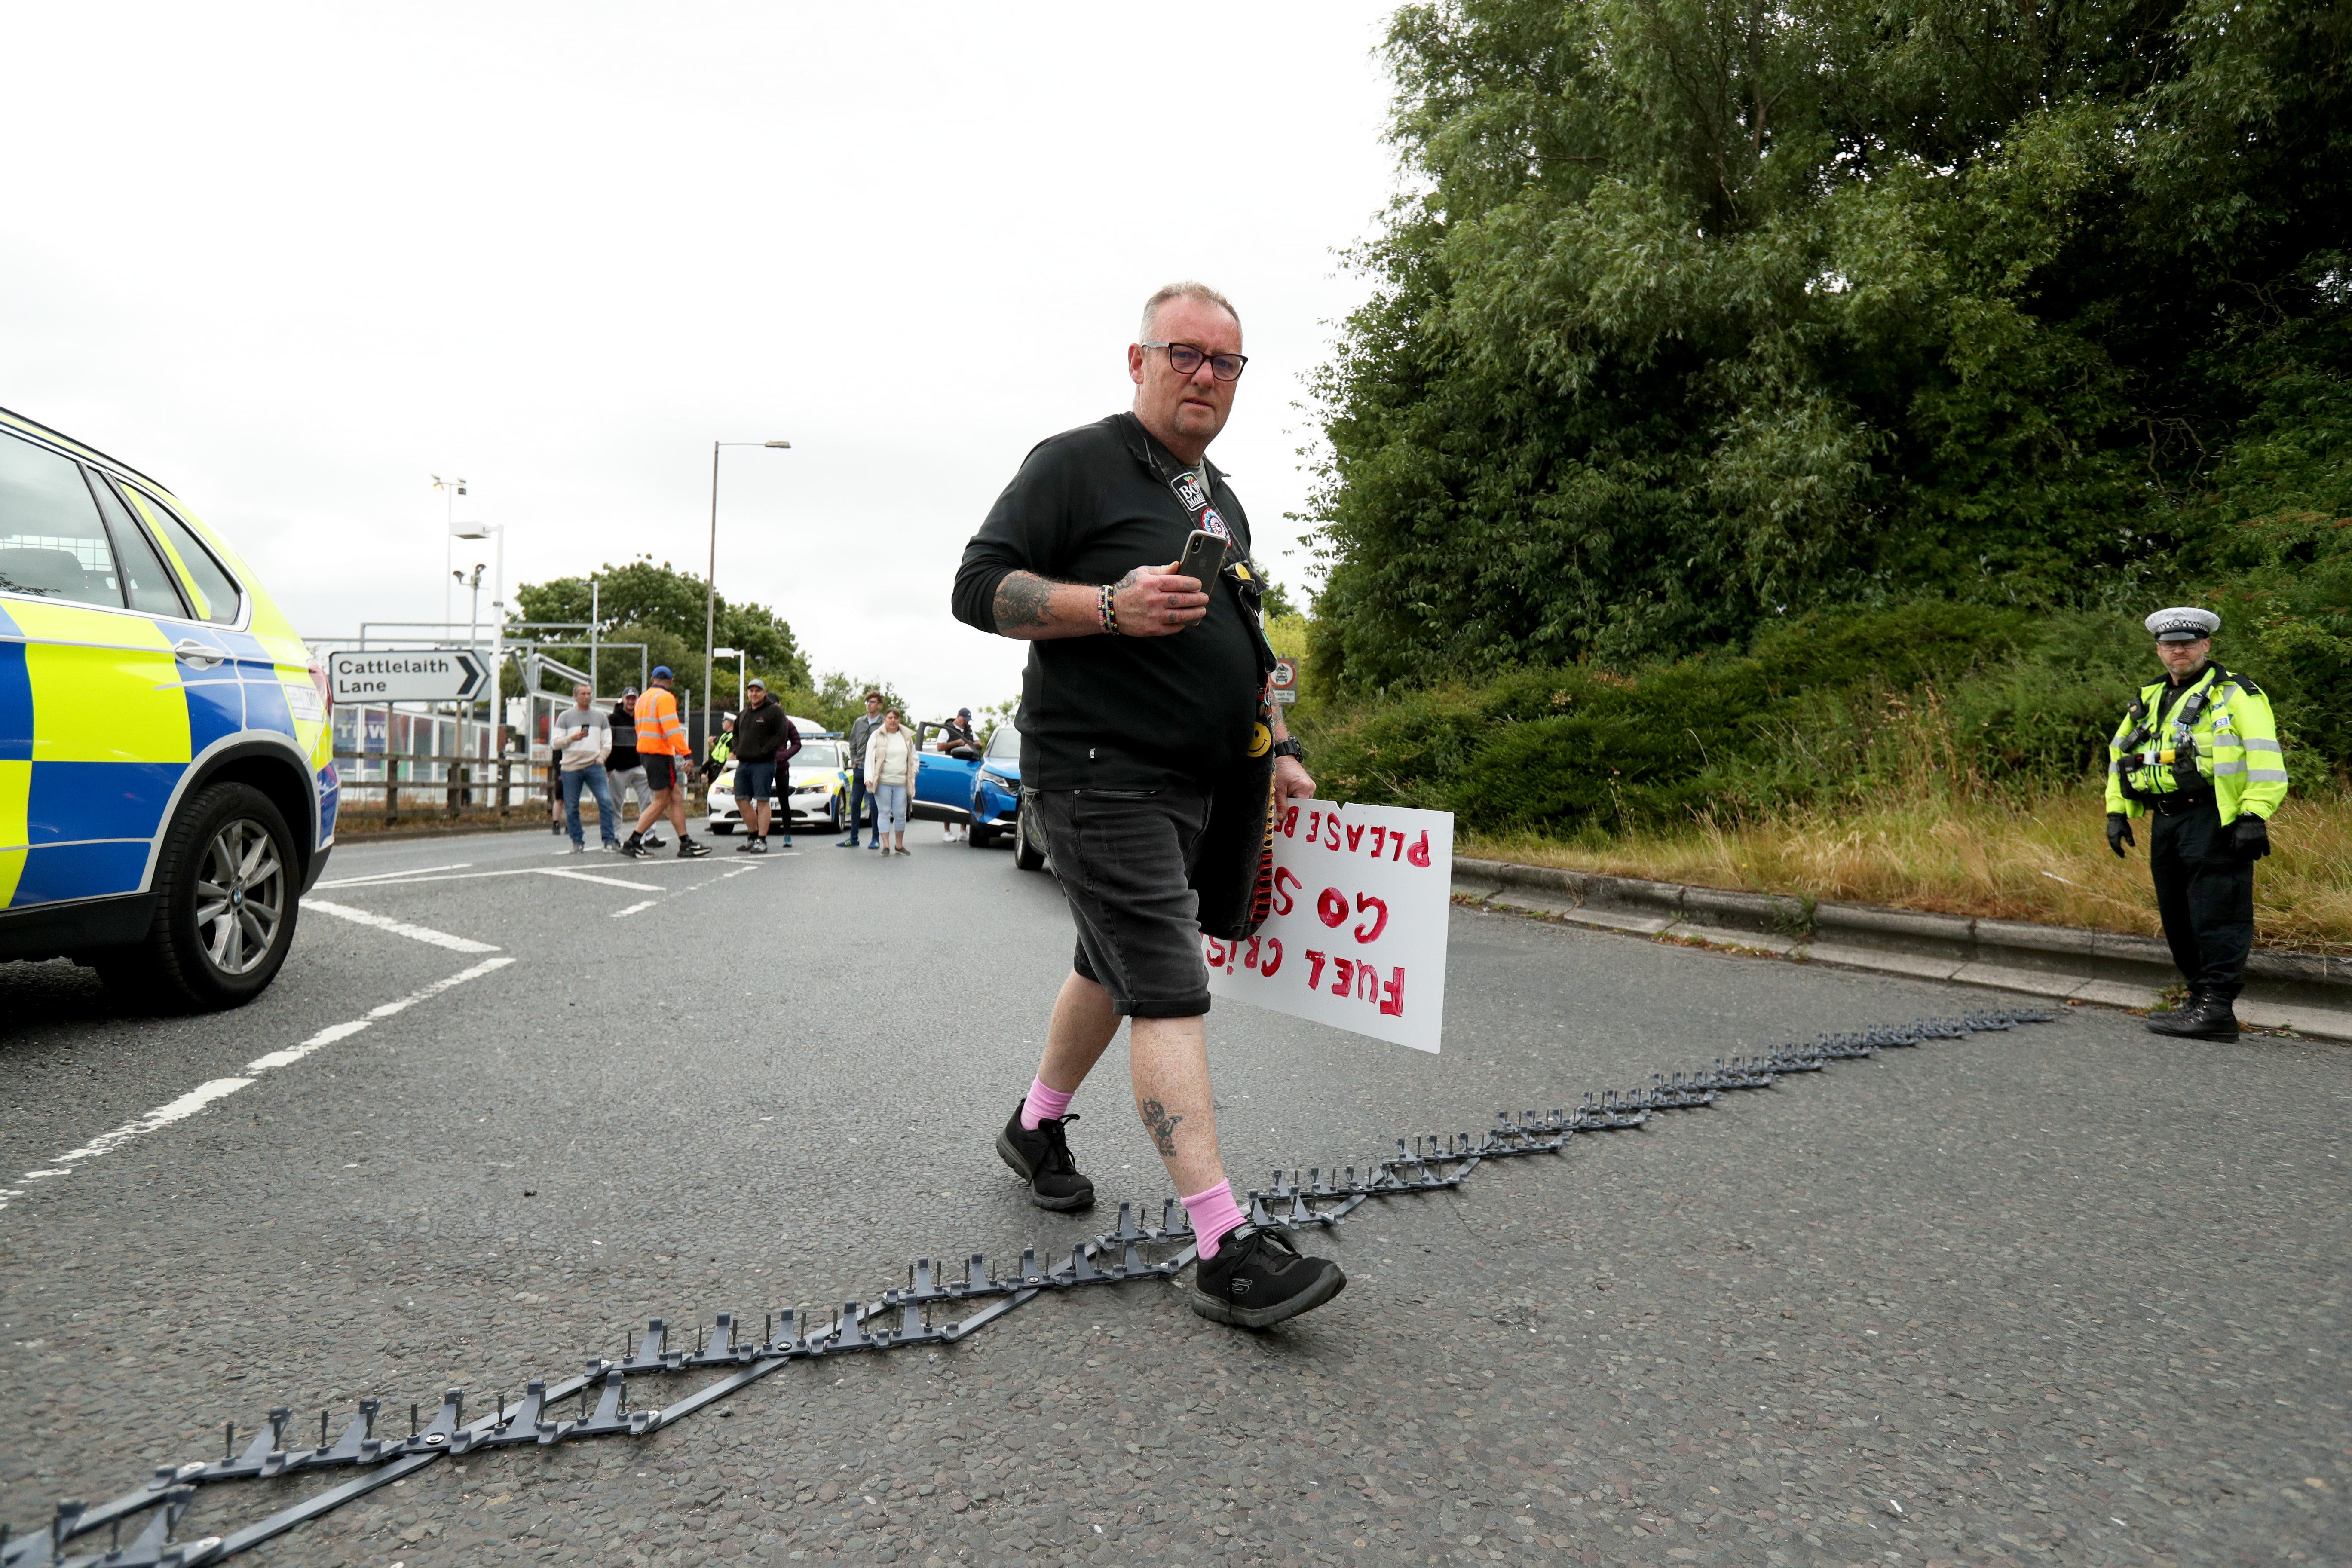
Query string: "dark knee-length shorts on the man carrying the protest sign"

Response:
xmin=1023 ymin=790 xmax=1209 ymax=1018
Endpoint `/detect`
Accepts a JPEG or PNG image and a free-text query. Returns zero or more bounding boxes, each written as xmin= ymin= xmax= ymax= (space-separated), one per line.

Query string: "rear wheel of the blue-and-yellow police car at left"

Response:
xmin=99 ymin=783 xmax=301 ymax=1011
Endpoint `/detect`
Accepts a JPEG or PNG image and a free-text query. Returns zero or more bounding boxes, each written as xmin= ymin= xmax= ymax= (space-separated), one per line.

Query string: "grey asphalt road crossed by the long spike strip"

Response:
xmin=0 ymin=825 xmax=2352 ymax=1568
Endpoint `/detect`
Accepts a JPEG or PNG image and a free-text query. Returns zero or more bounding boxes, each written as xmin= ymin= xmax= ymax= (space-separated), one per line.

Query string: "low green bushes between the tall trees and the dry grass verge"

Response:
xmin=1298 ymin=597 xmax=2352 ymax=837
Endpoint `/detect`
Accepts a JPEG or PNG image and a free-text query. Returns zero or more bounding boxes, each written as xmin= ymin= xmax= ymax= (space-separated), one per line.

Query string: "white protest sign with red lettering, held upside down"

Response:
xmin=1202 ymin=799 xmax=1454 ymax=1051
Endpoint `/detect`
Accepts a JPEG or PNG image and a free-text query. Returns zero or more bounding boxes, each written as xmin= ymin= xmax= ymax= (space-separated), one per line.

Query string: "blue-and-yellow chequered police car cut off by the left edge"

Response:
xmin=0 ymin=409 xmax=336 ymax=1008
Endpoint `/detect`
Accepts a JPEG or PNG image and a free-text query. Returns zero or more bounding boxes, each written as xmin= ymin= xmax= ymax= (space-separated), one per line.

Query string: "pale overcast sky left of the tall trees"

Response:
xmin=0 ymin=0 xmax=1395 ymax=717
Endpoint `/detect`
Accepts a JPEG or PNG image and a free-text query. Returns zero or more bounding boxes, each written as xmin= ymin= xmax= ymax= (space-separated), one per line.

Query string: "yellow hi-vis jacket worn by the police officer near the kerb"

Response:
xmin=2107 ymin=663 xmax=2286 ymax=823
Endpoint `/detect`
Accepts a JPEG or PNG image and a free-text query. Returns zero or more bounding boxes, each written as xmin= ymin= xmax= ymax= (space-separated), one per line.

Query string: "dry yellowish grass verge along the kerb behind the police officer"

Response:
xmin=1454 ymin=787 xmax=2352 ymax=955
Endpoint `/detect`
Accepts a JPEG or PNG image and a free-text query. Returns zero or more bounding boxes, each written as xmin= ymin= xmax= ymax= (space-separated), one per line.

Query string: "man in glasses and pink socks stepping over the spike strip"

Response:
xmin=955 ymin=282 xmax=1348 ymax=1328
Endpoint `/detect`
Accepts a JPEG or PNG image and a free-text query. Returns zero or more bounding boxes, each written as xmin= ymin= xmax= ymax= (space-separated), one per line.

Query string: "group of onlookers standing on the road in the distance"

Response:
xmin=548 ymin=668 xmax=981 ymax=858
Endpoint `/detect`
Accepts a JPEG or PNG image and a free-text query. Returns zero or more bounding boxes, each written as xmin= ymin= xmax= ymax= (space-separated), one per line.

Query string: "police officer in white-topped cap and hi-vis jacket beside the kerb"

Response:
xmin=2107 ymin=609 xmax=2286 ymax=1039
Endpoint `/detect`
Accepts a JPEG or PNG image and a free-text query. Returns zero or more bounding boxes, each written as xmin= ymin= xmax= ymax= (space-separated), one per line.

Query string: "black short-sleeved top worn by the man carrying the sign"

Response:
xmin=955 ymin=414 xmax=1261 ymax=790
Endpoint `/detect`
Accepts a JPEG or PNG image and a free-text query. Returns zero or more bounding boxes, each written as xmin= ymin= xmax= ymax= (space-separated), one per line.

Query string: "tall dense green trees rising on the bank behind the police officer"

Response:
xmin=1315 ymin=0 xmax=2352 ymax=691
